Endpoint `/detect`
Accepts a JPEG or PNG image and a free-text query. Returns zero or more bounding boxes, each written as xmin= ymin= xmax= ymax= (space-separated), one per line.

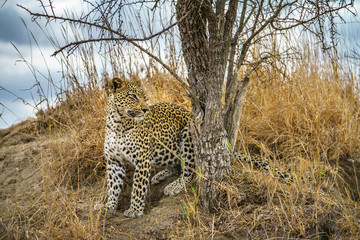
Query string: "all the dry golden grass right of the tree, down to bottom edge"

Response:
xmin=176 ymin=48 xmax=360 ymax=239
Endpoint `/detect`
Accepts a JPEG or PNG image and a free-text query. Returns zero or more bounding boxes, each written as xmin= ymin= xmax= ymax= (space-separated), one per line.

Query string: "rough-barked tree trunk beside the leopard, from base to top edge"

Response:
xmin=176 ymin=0 xmax=231 ymax=211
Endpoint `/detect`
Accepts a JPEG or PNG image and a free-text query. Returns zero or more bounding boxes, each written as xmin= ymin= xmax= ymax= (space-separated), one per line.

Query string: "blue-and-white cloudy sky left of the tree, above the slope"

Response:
xmin=0 ymin=0 xmax=105 ymax=128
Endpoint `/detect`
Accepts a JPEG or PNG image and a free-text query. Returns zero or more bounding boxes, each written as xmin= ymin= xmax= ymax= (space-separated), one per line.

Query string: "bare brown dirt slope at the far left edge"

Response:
xmin=0 ymin=120 xmax=46 ymax=239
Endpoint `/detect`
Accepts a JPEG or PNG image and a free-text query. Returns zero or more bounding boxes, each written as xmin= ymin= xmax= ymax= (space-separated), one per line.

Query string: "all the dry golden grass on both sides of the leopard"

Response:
xmin=4 ymin=40 xmax=360 ymax=239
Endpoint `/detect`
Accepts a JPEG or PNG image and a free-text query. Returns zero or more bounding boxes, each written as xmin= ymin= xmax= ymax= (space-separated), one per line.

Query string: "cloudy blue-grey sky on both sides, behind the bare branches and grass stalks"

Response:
xmin=0 ymin=0 xmax=360 ymax=129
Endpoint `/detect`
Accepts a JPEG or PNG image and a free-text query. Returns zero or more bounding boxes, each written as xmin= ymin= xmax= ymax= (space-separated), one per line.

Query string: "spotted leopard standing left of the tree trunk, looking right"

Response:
xmin=104 ymin=77 xmax=195 ymax=218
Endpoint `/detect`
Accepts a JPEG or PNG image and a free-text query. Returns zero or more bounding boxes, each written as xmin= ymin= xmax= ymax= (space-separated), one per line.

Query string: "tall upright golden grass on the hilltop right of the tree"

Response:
xmin=242 ymin=52 xmax=360 ymax=161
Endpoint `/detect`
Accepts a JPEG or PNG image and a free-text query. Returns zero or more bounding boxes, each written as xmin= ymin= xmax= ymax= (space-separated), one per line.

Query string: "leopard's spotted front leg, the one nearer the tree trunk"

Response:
xmin=124 ymin=158 xmax=150 ymax=218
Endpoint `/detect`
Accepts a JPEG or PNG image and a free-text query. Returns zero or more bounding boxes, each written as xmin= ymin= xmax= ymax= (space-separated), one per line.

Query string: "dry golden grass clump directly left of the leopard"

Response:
xmin=40 ymin=88 xmax=106 ymax=187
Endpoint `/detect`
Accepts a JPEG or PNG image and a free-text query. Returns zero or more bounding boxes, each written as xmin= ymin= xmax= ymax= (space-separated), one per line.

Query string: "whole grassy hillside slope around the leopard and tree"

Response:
xmin=0 ymin=61 xmax=360 ymax=239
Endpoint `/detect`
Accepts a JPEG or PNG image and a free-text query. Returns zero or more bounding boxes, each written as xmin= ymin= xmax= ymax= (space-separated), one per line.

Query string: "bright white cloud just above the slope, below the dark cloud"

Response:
xmin=0 ymin=39 xmax=61 ymax=128
